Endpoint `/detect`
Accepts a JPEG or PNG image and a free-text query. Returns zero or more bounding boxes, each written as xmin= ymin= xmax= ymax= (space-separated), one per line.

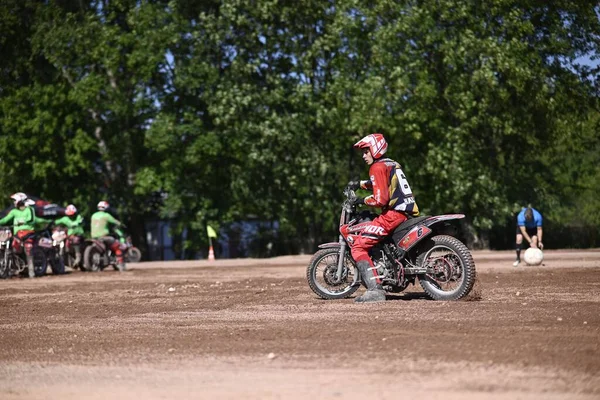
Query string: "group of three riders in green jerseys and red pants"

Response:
xmin=0 ymin=192 xmax=125 ymax=278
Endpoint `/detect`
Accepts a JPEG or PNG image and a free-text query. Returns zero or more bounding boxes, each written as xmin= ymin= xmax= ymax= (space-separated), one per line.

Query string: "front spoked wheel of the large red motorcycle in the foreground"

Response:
xmin=306 ymin=248 xmax=360 ymax=300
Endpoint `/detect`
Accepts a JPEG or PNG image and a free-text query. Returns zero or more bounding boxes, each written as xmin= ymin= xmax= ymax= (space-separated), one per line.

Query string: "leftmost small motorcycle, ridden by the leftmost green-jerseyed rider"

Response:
xmin=0 ymin=227 xmax=48 ymax=279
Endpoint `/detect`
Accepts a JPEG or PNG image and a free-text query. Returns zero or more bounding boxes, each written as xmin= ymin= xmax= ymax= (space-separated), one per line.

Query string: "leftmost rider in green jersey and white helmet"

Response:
xmin=0 ymin=192 xmax=51 ymax=278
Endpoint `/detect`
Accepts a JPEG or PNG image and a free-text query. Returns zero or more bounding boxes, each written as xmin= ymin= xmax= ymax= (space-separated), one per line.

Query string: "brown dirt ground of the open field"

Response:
xmin=0 ymin=250 xmax=600 ymax=400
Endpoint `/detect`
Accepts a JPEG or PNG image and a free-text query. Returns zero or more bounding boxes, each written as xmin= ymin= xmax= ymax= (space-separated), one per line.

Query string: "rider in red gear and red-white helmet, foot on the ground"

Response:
xmin=348 ymin=133 xmax=419 ymax=303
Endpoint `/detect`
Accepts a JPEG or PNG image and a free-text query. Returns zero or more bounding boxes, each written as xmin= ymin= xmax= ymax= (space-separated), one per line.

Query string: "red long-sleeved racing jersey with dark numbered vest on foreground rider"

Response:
xmin=360 ymin=158 xmax=419 ymax=216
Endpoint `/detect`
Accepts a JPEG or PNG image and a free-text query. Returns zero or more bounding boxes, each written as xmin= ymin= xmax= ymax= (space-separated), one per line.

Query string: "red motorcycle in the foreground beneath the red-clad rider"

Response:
xmin=306 ymin=188 xmax=476 ymax=300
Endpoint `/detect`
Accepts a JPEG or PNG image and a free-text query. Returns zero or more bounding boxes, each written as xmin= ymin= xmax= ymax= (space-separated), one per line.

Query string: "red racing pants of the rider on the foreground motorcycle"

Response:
xmin=350 ymin=210 xmax=408 ymax=284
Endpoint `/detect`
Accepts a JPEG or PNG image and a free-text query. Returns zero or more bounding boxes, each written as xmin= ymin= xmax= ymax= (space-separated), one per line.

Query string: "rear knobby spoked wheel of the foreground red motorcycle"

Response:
xmin=417 ymin=235 xmax=476 ymax=300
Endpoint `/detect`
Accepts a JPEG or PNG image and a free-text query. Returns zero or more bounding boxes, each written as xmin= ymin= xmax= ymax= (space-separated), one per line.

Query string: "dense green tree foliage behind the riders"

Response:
xmin=0 ymin=0 xmax=600 ymax=252
